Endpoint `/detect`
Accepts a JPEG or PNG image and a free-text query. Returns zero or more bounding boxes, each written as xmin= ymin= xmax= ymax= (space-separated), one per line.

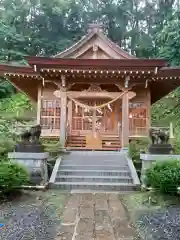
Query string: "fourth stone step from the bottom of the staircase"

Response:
xmin=60 ymin=164 xmax=129 ymax=171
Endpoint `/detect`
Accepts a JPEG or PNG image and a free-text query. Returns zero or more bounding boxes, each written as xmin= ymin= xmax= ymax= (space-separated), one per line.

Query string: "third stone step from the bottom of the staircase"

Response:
xmin=57 ymin=169 xmax=130 ymax=176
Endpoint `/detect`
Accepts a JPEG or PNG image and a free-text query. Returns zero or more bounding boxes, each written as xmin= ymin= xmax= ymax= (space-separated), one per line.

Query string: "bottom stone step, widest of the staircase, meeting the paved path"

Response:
xmin=51 ymin=182 xmax=138 ymax=191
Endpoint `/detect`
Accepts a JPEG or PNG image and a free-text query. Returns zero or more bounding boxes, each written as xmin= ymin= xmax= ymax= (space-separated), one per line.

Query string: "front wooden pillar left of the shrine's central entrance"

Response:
xmin=60 ymin=91 xmax=67 ymax=147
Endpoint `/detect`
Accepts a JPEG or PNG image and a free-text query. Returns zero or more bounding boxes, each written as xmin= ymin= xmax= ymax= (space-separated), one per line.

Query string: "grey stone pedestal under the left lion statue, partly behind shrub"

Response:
xmin=8 ymin=152 xmax=49 ymax=185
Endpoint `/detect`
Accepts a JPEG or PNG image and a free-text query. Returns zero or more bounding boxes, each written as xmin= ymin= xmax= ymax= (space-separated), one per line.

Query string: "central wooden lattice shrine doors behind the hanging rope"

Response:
xmin=72 ymin=100 xmax=117 ymax=135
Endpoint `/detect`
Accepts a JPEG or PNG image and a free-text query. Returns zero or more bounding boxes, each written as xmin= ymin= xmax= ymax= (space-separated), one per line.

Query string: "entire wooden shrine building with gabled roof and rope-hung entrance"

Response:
xmin=0 ymin=24 xmax=180 ymax=150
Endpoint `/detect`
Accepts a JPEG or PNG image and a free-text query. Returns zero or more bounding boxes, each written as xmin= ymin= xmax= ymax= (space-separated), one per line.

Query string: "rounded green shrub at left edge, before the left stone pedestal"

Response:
xmin=0 ymin=161 xmax=29 ymax=192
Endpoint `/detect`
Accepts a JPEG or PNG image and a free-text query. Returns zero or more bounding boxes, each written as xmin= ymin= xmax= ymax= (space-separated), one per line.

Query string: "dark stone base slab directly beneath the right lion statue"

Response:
xmin=148 ymin=144 xmax=174 ymax=154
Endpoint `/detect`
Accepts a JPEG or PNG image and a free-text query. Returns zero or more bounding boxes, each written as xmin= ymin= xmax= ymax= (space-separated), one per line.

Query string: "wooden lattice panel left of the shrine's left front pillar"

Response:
xmin=41 ymin=99 xmax=61 ymax=131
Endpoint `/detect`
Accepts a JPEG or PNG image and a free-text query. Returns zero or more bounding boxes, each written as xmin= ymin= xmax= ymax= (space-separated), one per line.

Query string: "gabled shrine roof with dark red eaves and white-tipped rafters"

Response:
xmin=0 ymin=25 xmax=180 ymax=103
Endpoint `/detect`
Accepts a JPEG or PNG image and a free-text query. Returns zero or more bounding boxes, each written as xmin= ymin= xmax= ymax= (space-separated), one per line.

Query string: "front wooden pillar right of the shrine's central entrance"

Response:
xmin=121 ymin=92 xmax=129 ymax=147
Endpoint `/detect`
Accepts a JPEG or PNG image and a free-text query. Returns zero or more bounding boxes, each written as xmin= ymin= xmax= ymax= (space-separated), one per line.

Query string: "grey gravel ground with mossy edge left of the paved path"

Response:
xmin=0 ymin=192 xmax=68 ymax=240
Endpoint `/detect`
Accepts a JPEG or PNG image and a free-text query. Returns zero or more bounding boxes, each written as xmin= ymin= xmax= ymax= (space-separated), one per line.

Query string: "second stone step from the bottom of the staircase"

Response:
xmin=56 ymin=175 xmax=132 ymax=183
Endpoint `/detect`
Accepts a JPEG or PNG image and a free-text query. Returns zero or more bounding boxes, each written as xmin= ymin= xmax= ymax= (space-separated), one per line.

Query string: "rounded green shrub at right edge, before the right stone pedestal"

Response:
xmin=145 ymin=160 xmax=180 ymax=194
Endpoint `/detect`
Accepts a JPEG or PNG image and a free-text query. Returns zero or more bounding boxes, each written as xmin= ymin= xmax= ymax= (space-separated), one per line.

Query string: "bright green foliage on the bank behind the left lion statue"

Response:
xmin=0 ymin=93 xmax=35 ymax=157
